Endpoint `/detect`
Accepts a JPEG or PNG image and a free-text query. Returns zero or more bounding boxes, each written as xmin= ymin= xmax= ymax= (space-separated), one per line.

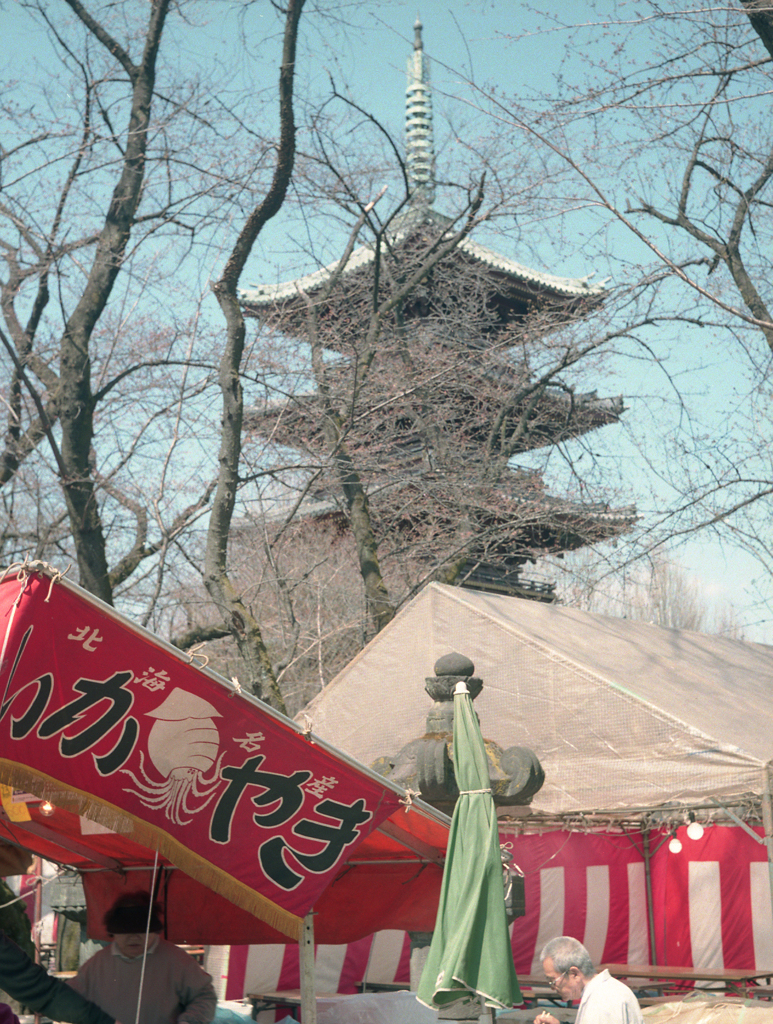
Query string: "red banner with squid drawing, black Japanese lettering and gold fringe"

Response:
xmin=0 ymin=573 xmax=407 ymax=936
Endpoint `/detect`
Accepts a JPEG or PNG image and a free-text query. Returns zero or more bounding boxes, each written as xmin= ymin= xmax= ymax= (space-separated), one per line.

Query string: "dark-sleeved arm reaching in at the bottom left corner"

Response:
xmin=0 ymin=931 xmax=116 ymax=1024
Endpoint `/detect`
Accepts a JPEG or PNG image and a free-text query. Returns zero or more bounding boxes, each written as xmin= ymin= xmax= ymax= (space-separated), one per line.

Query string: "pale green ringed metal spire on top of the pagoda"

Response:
xmin=405 ymin=17 xmax=435 ymax=206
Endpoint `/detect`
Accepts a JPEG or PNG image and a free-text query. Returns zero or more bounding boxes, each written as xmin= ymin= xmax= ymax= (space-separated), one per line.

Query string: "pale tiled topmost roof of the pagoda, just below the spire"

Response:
xmin=239 ymin=202 xmax=606 ymax=316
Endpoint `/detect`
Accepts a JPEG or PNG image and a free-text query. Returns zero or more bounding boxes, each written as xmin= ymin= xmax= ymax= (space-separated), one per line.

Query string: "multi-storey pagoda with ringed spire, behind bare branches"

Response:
xmin=240 ymin=22 xmax=636 ymax=601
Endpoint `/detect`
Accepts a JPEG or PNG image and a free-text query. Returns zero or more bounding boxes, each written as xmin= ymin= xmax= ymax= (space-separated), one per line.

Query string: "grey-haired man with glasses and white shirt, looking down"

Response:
xmin=534 ymin=935 xmax=644 ymax=1024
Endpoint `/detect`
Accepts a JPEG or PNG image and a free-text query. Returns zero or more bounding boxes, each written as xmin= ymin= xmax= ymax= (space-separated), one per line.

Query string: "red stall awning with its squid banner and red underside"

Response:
xmin=0 ymin=571 xmax=448 ymax=943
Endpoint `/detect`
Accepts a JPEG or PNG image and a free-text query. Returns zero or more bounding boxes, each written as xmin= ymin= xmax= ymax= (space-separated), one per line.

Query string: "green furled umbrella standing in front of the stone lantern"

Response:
xmin=417 ymin=682 xmax=522 ymax=1010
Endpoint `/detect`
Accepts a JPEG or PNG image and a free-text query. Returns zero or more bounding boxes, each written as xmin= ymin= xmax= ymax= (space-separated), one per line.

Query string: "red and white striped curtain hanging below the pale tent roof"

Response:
xmin=226 ymin=825 xmax=773 ymax=1003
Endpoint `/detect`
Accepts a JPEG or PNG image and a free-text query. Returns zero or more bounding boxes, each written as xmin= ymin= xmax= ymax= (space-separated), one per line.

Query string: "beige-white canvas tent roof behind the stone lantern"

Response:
xmin=299 ymin=584 xmax=773 ymax=814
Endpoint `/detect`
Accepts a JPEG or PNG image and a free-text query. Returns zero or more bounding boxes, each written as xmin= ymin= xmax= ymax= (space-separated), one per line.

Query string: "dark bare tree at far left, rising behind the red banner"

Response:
xmin=2 ymin=0 xmax=175 ymax=602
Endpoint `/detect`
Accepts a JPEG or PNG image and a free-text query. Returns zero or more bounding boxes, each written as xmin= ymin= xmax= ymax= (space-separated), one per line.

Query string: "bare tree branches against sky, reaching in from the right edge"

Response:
xmin=452 ymin=0 xmax=773 ymax=622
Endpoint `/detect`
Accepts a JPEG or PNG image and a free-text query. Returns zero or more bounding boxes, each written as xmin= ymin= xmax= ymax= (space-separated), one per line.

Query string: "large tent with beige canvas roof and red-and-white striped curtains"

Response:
xmin=229 ymin=584 xmax=773 ymax=992
